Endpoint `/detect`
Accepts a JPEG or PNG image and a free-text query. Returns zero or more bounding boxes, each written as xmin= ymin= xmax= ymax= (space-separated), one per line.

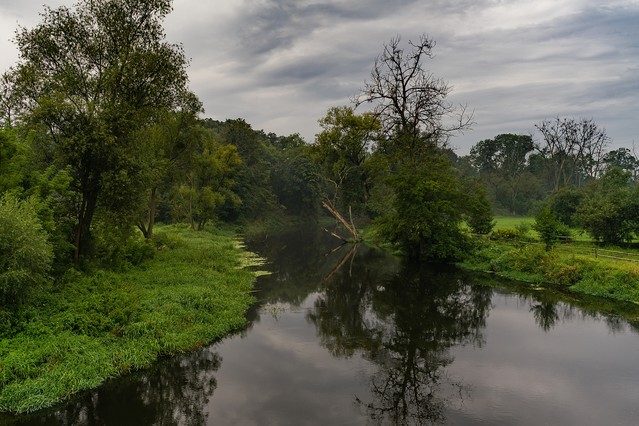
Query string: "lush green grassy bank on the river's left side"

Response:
xmin=0 ymin=226 xmax=255 ymax=413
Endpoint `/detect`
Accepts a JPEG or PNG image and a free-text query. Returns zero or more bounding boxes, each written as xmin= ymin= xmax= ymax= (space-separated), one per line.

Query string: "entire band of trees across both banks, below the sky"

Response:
xmin=0 ymin=0 xmax=636 ymax=324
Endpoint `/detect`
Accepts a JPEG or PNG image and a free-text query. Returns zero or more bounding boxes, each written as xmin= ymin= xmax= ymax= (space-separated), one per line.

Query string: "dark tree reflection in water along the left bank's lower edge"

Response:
xmin=17 ymin=348 xmax=222 ymax=426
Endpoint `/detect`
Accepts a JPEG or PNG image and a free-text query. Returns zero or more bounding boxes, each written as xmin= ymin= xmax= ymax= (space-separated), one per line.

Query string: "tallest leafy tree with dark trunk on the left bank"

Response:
xmin=9 ymin=0 xmax=194 ymax=263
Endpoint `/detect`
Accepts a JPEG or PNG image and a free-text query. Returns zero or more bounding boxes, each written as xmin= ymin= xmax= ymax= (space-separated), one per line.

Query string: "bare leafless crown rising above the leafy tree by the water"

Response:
xmin=352 ymin=35 xmax=472 ymax=149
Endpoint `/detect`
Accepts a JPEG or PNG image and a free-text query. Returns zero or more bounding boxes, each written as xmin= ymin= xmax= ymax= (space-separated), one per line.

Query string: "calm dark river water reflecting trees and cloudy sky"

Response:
xmin=0 ymin=232 xmax=639 ymax=425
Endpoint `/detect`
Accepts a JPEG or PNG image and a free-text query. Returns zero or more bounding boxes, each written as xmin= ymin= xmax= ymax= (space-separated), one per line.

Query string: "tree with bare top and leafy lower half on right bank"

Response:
xmin=353 ymin=36 xmax=490 ymax=261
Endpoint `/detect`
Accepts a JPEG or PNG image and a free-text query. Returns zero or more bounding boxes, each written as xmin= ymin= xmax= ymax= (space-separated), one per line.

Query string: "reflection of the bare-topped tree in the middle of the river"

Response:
xmin=308 ymin=254 xmax=492 ymax=424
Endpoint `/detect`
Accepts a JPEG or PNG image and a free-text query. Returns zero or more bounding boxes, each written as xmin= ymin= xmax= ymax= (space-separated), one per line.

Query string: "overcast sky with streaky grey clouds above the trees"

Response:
xmin=0 ymin=0 xmax=639 ymax=154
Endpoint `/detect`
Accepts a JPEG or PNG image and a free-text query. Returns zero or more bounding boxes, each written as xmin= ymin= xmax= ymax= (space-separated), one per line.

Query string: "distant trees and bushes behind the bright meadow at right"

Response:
xmin=451 ymin=118 xmax=639 ymax=245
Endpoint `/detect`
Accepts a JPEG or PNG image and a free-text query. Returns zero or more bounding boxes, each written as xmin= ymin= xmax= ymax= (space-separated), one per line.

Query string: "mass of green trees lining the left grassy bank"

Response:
xmin=0 ymin=0 xmax=330 ymax=325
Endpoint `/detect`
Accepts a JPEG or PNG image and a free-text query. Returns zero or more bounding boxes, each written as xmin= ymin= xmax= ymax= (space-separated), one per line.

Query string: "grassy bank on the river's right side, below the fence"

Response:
xmin=458 ymin=239 xmax=639 ymax=304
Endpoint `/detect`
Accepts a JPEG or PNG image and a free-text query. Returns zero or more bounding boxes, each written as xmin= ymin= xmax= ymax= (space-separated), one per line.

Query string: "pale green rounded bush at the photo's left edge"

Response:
xmin=0 ymin=194 xmax=53 ymax=310
